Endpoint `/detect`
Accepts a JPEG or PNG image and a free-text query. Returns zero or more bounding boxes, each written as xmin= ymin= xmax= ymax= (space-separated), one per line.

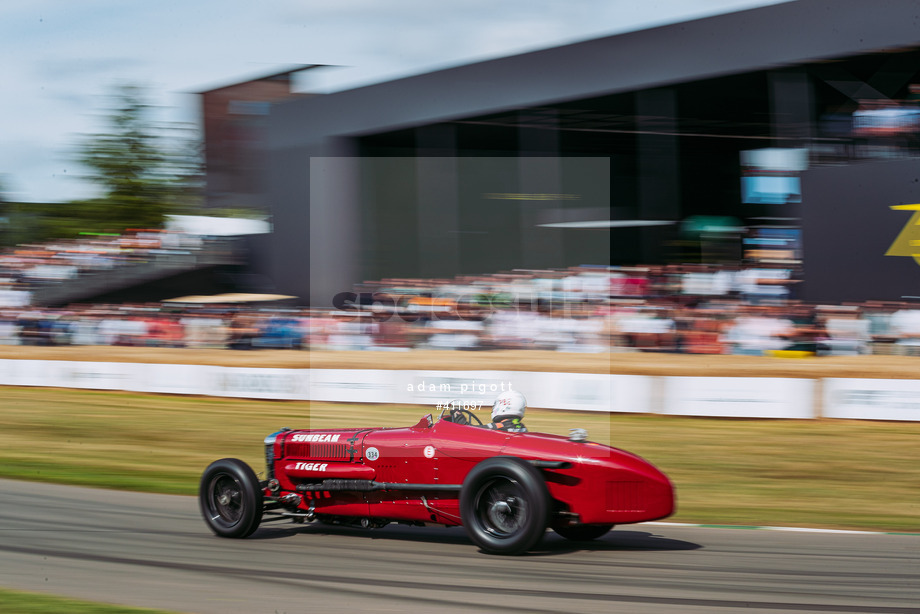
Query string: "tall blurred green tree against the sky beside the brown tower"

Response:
xmin=71 ymin=84 xmax=202 ymax=230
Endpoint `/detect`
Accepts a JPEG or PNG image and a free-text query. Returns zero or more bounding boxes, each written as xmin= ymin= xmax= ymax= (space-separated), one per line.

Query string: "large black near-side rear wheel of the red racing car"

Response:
xmin=460 ymin=456 xmax=550 ymax=554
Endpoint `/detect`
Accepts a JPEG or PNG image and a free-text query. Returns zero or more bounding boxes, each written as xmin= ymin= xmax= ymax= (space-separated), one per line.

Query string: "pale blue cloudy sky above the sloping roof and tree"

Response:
xmin=0 ymin=0 xmax=780 ymax=207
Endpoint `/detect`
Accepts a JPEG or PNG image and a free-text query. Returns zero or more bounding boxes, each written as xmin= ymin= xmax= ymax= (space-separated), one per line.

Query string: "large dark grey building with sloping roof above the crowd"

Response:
xmin=216 ymin=0 xmax=920 ymax=305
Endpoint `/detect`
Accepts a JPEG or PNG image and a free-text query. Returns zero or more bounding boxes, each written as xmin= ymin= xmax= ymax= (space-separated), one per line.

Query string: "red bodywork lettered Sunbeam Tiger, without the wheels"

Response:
xmin=264 ymin=415 xmax=674 ymax=525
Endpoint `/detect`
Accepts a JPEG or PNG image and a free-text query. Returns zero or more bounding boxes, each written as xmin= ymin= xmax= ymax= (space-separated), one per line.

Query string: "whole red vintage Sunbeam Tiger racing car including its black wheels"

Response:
xmin=199 ymin=407 xmax=674 ymax=554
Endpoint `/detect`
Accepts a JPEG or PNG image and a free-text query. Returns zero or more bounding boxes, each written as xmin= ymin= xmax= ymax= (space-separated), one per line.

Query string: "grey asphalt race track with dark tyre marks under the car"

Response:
xmin=0 ymin=480 xmax=920 ymax=614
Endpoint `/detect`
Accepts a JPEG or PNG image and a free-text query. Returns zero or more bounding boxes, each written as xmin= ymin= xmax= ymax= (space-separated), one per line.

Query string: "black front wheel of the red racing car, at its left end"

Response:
xmin=198 ymin=458 xmax=262 ymax=538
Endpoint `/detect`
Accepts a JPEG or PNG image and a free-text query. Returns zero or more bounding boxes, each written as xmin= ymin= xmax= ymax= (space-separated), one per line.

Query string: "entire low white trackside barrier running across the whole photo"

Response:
xmin=0 ymin=359 xmax=920 ymax=421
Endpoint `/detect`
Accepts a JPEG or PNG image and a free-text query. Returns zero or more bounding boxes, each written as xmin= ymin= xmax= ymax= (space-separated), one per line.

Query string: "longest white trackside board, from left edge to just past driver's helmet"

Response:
xmin=0 ymin=360 xmax=632 ymax=413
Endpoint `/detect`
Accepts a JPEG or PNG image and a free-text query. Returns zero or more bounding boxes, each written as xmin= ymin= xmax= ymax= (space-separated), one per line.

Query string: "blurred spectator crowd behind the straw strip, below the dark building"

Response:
xmin=0 ymin=265 xmax=920 ymax=356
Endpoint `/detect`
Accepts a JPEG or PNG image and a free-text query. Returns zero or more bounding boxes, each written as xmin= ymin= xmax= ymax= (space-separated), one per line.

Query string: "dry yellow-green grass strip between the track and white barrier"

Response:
xmin=0 ymin=387 xmax=920 ymax=536
